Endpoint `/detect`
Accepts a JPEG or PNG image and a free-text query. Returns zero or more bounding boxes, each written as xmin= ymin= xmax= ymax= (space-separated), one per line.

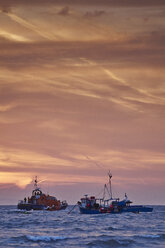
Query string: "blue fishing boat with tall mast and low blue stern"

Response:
xmin=78 ymin=171 xmax=153 ymax=214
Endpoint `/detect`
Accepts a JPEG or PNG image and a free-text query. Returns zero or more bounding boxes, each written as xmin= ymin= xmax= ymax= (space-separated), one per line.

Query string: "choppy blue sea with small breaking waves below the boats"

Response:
xmin=0 ymin=206 xmax=165 ymax=248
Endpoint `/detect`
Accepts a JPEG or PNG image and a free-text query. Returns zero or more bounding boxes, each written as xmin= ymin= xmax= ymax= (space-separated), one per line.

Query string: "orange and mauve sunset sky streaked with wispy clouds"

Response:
xmin=0 ymin=0 xmax=165 ymax=204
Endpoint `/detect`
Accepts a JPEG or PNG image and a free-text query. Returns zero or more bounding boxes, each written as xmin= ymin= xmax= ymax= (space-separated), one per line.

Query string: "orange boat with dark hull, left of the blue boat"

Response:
xmin=17 ymin=177 xmax=68 ymax=211
